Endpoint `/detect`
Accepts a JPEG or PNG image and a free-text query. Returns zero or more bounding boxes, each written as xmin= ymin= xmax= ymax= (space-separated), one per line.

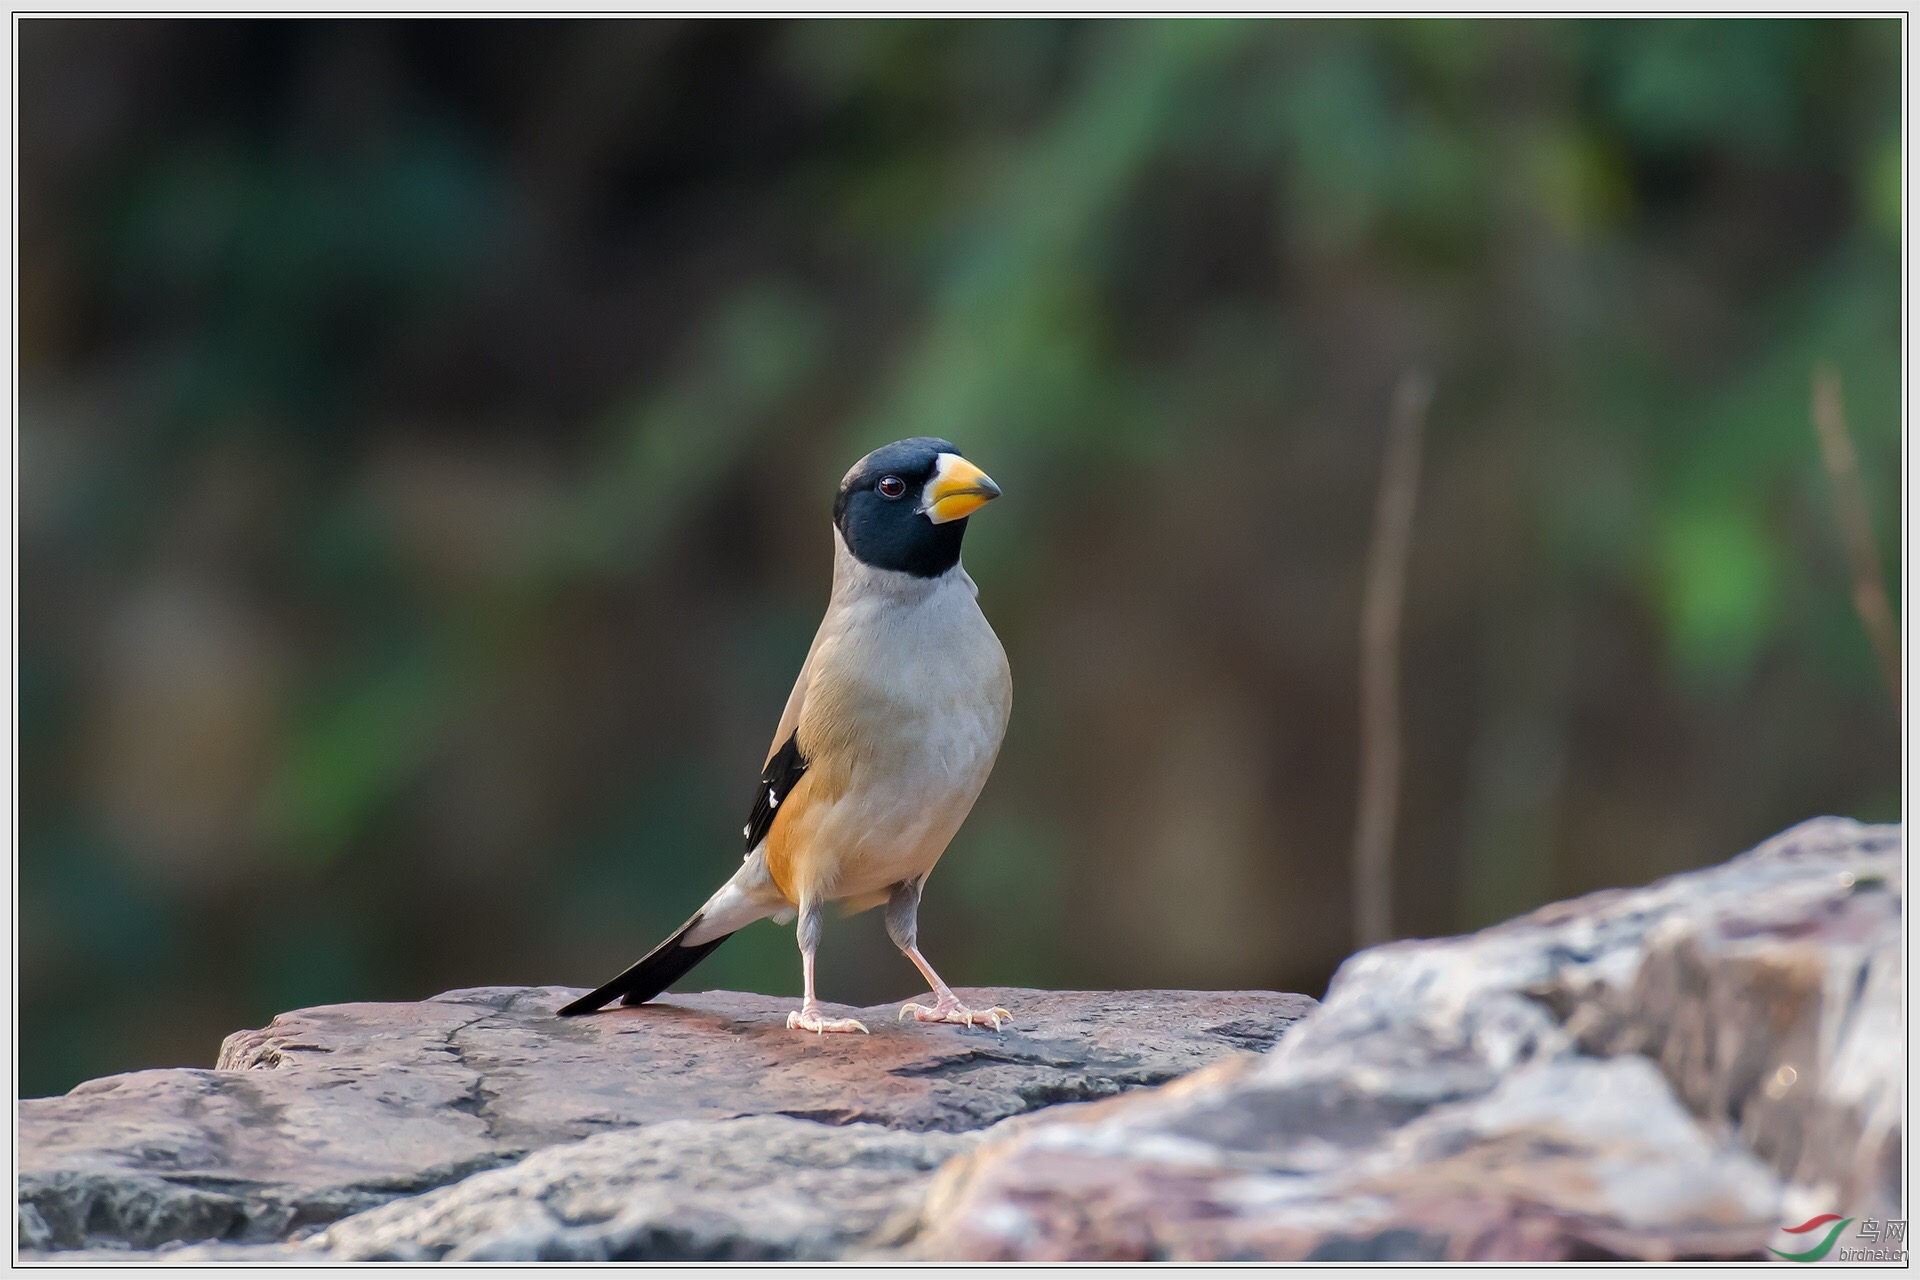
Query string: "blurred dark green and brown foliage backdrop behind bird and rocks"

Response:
xmin=17 ymin=19 xmax=1903 ymax=1094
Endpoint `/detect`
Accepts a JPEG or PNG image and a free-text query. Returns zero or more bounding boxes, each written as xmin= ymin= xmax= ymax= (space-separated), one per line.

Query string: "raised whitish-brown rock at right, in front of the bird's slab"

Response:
xmin=910 ymin=819 xmax=1905 ymax=1261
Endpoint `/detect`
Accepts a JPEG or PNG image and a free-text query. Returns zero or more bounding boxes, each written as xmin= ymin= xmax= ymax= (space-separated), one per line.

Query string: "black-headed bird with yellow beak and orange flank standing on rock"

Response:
xmin=561 ymin=436 xmax=1014 ymax=1034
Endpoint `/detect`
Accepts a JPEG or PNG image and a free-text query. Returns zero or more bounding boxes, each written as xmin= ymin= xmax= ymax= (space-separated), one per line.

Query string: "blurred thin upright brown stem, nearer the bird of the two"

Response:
xmin=1354 ymin=368 xmax=1434 ymax=946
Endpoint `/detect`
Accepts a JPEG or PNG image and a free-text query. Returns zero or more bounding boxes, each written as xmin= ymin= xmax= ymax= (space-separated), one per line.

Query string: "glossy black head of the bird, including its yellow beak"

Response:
xmin=833 ymin=436 xmax=1000 ymax=578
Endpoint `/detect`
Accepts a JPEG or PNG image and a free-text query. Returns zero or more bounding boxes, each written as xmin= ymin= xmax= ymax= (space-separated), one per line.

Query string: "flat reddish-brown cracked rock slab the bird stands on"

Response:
xmin=17 ymin=986 xmax=1313 ymax=1249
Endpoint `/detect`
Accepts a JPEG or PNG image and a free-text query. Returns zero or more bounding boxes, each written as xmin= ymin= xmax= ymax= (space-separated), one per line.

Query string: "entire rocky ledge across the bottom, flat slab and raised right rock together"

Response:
xmin=19 ymin=819 xmax=1905 ymax=1261
